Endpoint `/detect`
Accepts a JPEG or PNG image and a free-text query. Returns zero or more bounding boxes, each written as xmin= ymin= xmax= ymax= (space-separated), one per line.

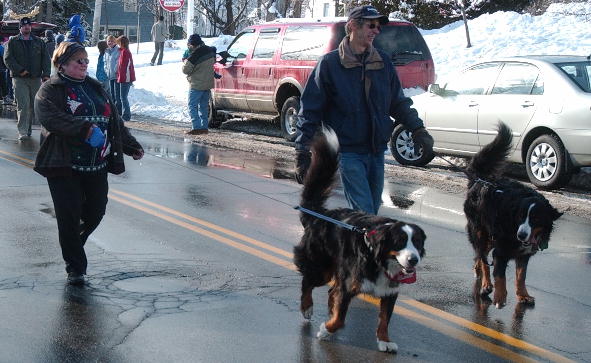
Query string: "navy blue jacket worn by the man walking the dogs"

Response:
xmin=296 ymin=38 xmax=423 ymax=153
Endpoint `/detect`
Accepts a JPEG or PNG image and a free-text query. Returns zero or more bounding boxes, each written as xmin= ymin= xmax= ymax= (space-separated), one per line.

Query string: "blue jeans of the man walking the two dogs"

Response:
xmin=339 ymin=151 xmax=384 ymax=214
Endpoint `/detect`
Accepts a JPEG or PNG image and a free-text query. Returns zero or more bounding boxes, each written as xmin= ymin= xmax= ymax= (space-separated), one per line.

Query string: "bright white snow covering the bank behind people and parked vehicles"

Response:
xmin=87 ymin=1 xmax=591 ymax=124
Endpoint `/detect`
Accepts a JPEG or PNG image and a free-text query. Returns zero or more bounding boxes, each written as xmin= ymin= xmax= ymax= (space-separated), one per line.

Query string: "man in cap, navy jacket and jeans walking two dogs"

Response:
xmin=295 ymin=6 xmax=433 ymax=214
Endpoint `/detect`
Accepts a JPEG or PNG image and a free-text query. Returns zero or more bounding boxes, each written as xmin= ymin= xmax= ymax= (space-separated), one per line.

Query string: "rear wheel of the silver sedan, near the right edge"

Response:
xmin=525 ymin=135 xmax=572 ymax=189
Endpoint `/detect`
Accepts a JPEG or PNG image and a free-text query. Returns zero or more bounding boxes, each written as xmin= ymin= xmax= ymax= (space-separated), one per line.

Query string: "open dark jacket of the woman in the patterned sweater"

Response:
xmin=34 ymin=75 xmax=142 ymax=177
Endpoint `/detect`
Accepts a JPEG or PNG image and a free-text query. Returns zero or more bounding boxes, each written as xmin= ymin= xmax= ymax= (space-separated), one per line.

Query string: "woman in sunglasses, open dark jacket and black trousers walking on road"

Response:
xmin=34 ymin=42 xmax=144 ymax=285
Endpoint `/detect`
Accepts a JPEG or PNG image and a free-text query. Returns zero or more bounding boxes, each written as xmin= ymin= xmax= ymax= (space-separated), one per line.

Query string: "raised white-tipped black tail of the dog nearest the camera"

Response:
xmin=300 ymin=127 xmax=339 ymax=222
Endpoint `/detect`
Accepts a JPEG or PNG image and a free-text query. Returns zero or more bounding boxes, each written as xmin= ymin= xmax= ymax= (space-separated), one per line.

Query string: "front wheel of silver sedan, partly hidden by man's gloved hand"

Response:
xmin=390 ymin=125 xmax=435 ymax=166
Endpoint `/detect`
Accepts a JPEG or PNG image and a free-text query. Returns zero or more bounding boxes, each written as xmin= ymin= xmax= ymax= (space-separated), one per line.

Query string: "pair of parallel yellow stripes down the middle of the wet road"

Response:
xmin=0 ymin=150 xmax=572 ymax=362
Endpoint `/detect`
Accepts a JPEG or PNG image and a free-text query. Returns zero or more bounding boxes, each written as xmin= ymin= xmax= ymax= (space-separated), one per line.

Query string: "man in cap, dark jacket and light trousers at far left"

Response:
xmin=4 ymin=17 xmax=50 ymax=140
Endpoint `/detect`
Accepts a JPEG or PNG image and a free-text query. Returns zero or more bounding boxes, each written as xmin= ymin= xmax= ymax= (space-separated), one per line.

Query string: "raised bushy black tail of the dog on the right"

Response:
xmin=466 ymin=122 xmax=513 ymax=180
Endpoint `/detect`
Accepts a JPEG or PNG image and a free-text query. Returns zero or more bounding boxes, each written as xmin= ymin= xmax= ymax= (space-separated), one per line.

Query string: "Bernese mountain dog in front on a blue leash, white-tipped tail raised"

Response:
xmin=294 ymin=129 xmax=426 ymax=352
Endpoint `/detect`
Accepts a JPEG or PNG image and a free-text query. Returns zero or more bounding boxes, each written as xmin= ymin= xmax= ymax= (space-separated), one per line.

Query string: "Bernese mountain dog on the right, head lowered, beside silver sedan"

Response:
xmin=464 ymin=123 xmax=562 ymax=308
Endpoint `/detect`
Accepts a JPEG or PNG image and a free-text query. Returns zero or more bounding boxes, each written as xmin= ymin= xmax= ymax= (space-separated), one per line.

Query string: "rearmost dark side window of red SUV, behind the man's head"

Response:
xmin=336 ymin=23 xmax=431 ymax=66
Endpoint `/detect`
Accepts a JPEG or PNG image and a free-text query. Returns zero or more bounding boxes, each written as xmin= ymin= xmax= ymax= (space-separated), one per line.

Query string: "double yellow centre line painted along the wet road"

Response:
xmin=0 ymin=150 xmax=573 ymax=362
